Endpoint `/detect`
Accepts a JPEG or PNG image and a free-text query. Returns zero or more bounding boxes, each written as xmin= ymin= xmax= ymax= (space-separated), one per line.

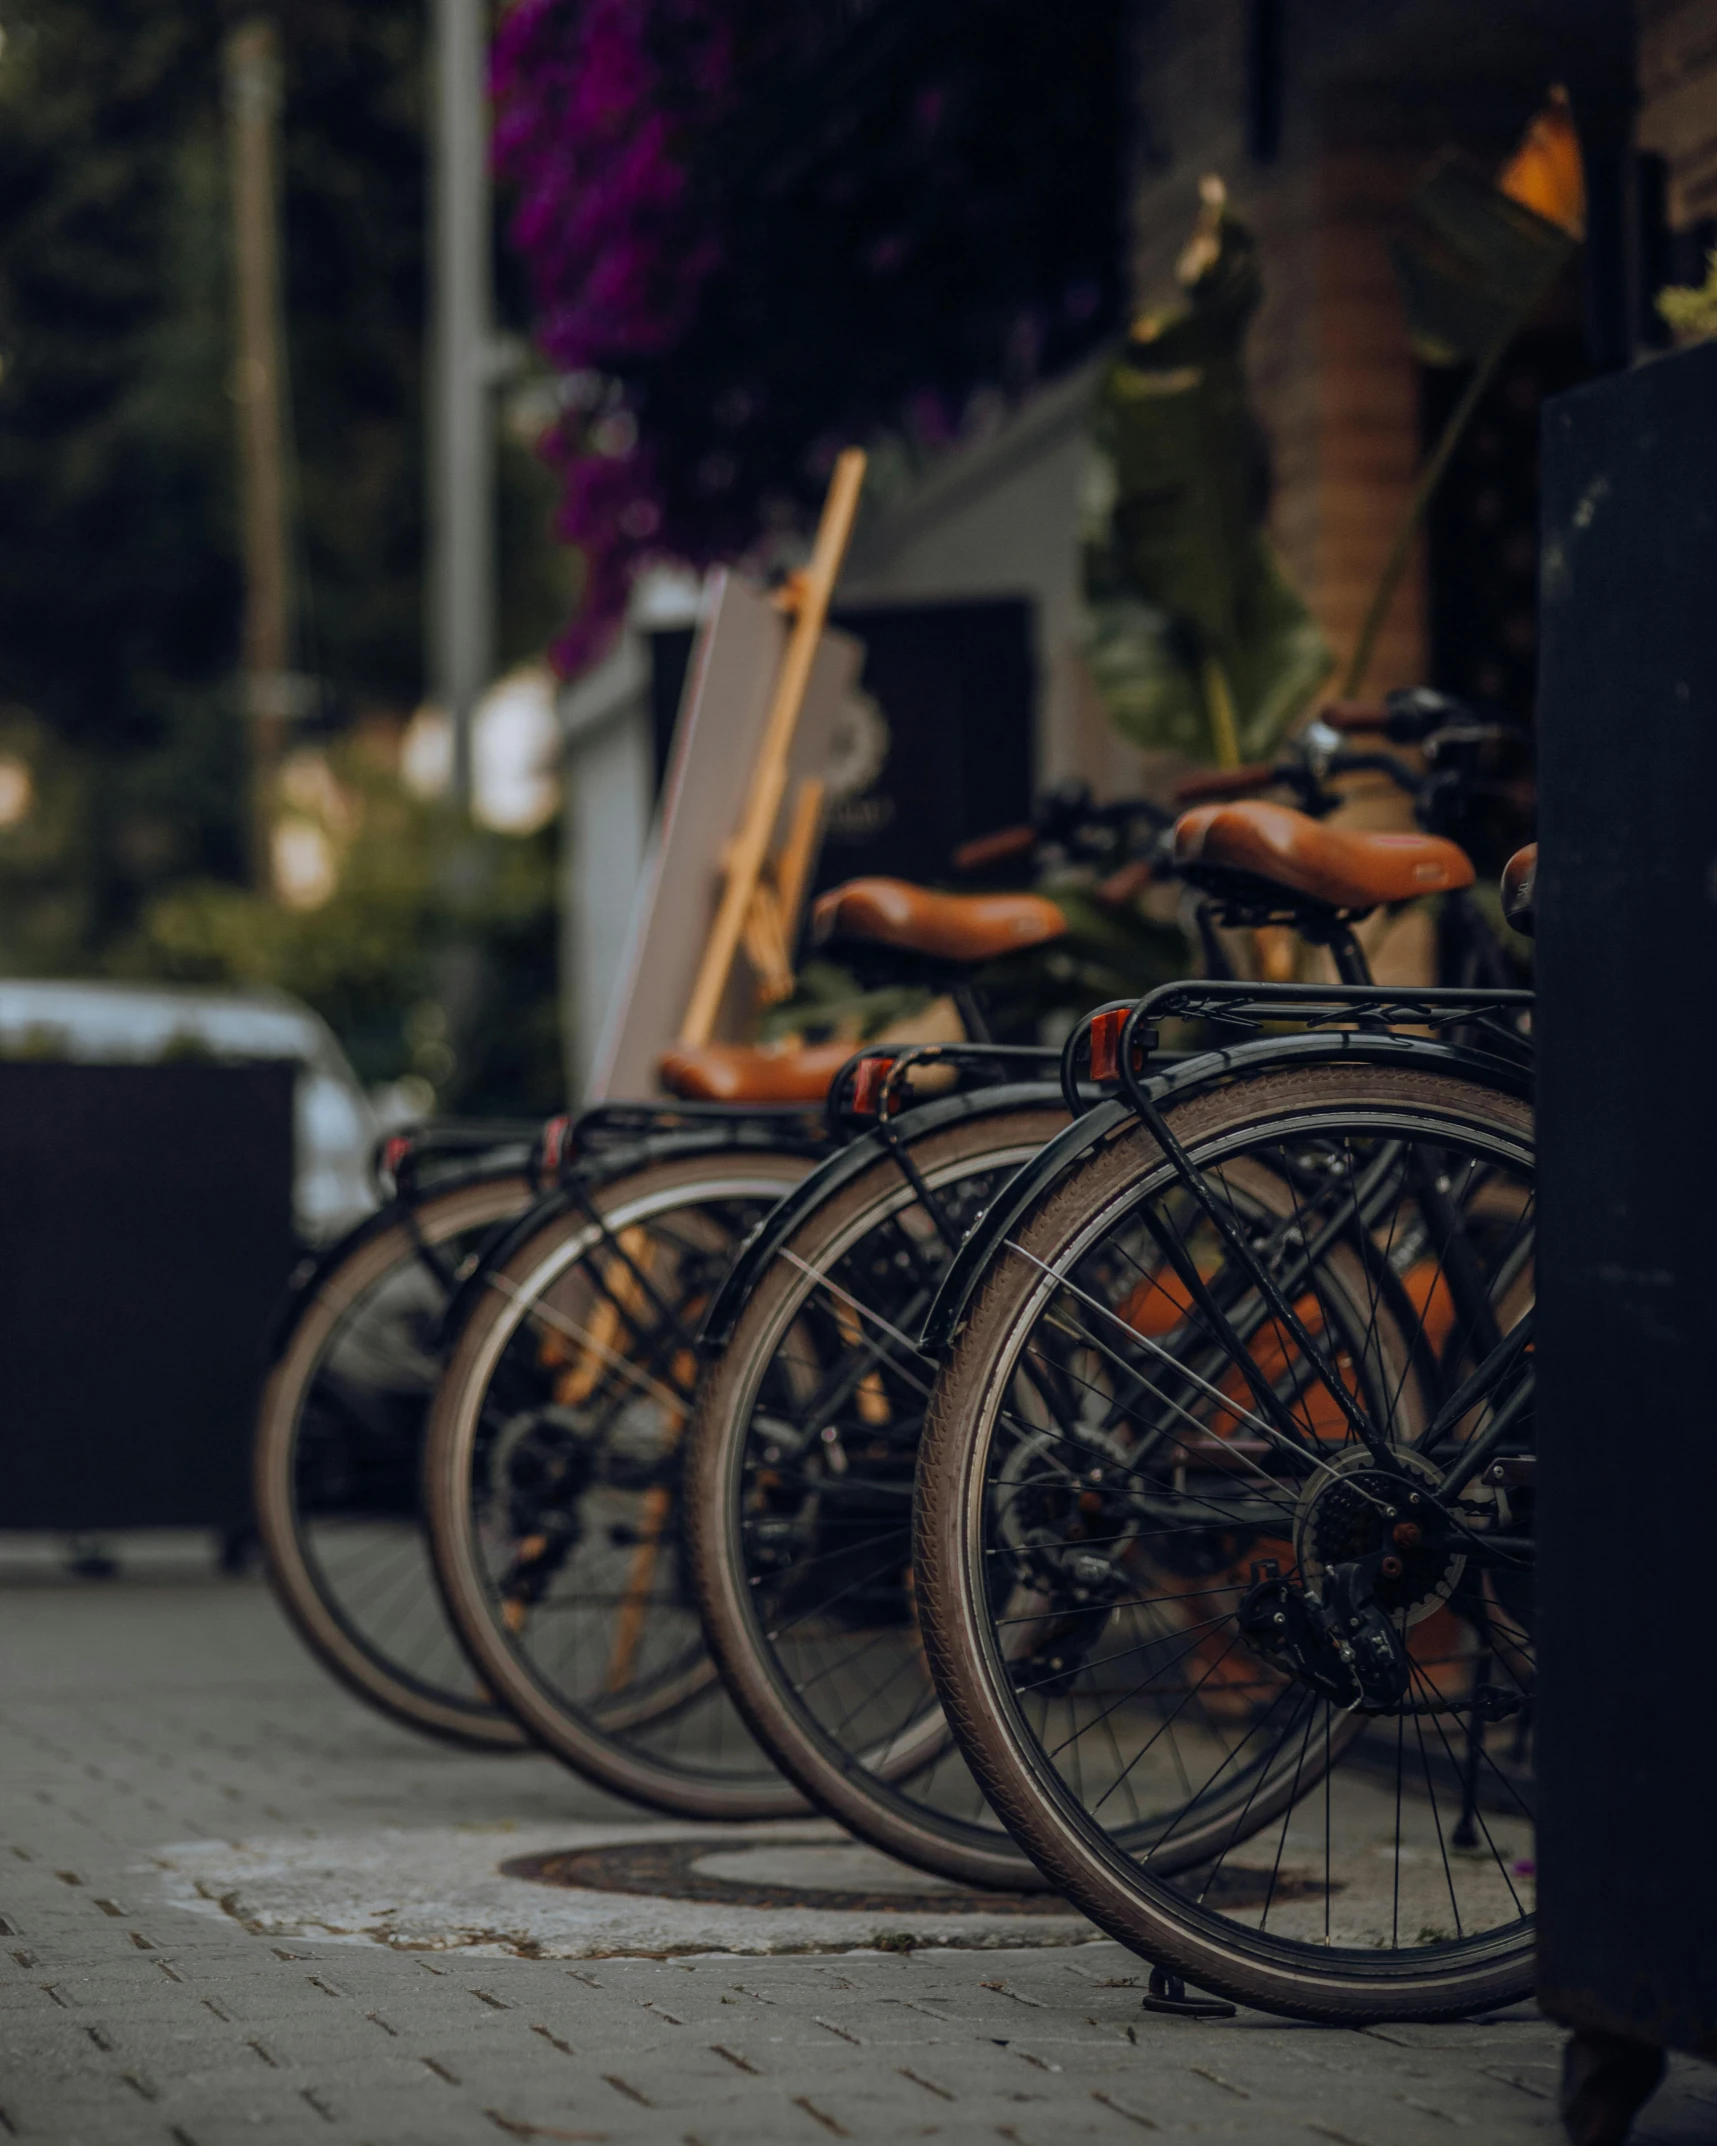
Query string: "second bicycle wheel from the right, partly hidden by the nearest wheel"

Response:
xmin=687 ymin=1103 xmax=1067 ymax=1888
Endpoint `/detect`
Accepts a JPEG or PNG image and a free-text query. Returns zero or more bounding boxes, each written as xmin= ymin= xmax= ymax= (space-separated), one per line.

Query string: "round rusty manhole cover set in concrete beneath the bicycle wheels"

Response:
xmin=500 ymin=1841 xmax=1073 ymax=1916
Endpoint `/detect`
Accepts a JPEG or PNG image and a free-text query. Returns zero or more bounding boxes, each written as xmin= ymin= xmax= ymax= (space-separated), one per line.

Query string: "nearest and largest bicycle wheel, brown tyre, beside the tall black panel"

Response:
xmin=916 ymin=1067 xmax=1535 ymax=2022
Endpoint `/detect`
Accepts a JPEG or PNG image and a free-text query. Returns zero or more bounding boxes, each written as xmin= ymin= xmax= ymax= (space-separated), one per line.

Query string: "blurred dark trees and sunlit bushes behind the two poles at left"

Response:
xmin=0 ymin=0 xmax=575 ymax=1109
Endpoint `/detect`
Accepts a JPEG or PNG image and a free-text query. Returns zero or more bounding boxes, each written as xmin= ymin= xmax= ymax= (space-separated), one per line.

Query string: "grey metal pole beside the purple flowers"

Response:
xmin=427 ymin=0 xmax=496 ymax=803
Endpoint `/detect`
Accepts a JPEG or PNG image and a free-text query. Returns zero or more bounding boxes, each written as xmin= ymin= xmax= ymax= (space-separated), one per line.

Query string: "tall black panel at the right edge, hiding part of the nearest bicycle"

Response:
xmin=1537 ymin=343 xmax=1717 ymax=2103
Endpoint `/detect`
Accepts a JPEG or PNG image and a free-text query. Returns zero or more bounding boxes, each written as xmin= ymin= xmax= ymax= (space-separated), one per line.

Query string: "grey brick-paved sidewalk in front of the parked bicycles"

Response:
xmin=0 ymin=1579 xmax=1717 ymax=2146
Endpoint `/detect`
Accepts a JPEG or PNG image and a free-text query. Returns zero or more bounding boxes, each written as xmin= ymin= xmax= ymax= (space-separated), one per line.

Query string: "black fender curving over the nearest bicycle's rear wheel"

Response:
xmin=919 ymin=1028 xmax=1532 ymax=1356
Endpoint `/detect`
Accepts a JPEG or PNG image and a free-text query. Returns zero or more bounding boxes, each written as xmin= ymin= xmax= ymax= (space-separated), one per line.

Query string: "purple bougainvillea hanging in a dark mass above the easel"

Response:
xmin=489 ymin=0 xmax=1122 ymax=672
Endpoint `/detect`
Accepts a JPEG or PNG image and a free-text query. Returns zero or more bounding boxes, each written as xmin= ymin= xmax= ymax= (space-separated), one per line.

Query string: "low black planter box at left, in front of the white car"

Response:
xmin=0 ymin=1060 xmax=298 ymax=1530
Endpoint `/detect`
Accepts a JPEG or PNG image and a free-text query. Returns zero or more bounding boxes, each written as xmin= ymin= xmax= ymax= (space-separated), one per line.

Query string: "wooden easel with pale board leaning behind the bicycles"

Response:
xmin=586 ymin=449 xmax=865 ymax=1103
